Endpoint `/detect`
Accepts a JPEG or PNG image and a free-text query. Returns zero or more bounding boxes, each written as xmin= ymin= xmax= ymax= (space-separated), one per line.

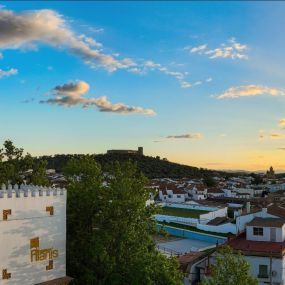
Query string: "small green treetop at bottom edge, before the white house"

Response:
xmin=202 ymin=246 xmax=258 ymax=285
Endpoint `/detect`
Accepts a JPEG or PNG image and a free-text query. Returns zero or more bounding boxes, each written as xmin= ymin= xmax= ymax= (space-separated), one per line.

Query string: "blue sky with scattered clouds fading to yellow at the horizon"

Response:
xmin=0 ymin=1 xmax=285 ymax=171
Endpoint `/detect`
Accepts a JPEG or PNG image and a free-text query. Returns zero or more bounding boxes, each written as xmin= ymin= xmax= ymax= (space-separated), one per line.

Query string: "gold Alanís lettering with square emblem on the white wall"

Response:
xmin=30 ymin=237 xmax=58 ymax=262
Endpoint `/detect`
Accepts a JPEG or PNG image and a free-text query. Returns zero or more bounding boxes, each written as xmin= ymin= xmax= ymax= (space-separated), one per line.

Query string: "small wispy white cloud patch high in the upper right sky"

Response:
xmin=185 ymin=38 xmax=248 ymax=59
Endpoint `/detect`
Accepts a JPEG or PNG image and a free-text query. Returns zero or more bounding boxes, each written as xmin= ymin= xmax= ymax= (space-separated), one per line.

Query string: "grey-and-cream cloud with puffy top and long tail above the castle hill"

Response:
xmin=40 ymin=81 xmax=156 ymax=116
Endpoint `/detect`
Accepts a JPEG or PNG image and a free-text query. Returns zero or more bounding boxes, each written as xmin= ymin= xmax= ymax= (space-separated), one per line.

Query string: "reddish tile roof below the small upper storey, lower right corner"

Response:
xmin=227 ymin=233 xmax=285 ymax=257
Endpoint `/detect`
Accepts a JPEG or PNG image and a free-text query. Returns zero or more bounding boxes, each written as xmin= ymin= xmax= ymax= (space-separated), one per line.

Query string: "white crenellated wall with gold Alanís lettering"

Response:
xmin=0 ymin=183 xmax=66 ymax=285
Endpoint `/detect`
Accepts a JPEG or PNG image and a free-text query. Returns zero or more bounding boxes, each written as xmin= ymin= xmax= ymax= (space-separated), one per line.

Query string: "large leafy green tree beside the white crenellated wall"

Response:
xmin=65 ymin=156 xmax=182 ymax=285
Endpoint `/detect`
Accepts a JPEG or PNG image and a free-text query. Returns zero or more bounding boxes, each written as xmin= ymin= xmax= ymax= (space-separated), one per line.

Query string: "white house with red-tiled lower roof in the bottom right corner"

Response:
xmin=229 ymin=218 xmax=285 ymax=285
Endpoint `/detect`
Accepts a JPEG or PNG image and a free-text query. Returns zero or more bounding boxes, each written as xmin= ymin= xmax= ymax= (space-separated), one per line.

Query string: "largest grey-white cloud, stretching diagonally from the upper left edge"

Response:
xmin=0 ymin=9 xmax=136 ymax=71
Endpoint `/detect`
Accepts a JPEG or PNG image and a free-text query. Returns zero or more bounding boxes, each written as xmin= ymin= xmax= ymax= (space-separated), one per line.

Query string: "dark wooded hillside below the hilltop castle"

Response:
xmin=41 ymin=153 xmax=230 ymax=178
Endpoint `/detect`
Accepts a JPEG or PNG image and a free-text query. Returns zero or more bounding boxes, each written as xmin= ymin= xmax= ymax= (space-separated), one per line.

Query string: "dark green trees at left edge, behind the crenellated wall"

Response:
xmin=0 ymin=140 xmax=49 ymax=185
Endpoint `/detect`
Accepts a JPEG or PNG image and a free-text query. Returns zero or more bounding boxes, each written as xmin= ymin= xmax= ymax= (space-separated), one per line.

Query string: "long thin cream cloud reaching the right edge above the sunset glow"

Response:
xmin=217 ymin=85 xmax=285 ymax=99
